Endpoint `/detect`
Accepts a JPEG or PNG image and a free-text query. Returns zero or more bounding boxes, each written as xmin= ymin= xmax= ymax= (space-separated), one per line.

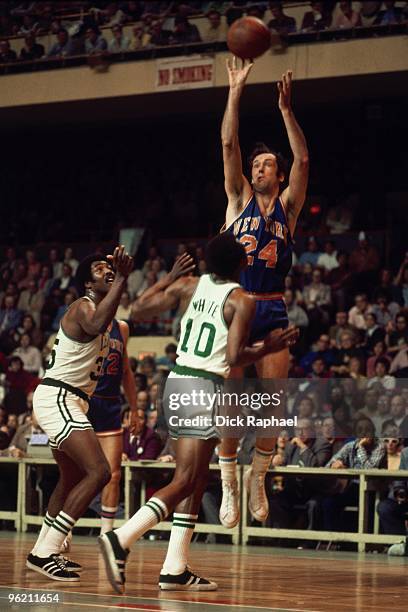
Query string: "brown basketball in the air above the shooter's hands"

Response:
xmin=227 ymin=17 xmax=271 ymax=59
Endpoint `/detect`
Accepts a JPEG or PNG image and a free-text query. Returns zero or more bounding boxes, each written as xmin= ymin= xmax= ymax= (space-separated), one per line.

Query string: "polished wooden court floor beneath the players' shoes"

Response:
xmin=0 ymin=532 xmax=408 ymax=612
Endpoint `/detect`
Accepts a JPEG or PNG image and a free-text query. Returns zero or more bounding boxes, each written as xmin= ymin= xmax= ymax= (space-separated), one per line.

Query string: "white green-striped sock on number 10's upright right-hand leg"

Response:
xmin=162 ymin=512 xmax=198 ymax=575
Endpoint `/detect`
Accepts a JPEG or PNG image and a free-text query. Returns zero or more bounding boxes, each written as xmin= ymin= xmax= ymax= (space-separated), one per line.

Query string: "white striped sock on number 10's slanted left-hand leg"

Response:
xmin=115 ymin=497 xmax=169 ymax=548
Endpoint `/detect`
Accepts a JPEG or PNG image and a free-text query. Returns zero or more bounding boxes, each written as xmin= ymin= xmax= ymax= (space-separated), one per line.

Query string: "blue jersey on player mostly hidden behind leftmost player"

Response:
xmin=94 ymin=319 xmax=124 ymax=397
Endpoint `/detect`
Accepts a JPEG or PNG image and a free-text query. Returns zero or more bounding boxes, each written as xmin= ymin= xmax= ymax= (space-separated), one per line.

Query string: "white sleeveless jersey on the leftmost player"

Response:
xmin=45 ymin=298 xmax=109 ymax=396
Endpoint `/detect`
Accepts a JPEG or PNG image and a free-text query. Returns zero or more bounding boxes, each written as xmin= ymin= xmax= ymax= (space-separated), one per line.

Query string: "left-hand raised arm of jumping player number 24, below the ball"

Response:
xmin=221 ymin=57 xmax=253 ymax=227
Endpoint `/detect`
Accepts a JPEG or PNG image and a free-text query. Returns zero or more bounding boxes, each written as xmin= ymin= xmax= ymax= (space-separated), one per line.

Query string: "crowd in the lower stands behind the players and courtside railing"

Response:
xmin=0 ymin=232 xmax=408 ymax=544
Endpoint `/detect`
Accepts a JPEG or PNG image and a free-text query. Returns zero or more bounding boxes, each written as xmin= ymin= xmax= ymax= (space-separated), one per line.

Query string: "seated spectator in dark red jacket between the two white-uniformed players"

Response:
xmin=122 ymin=409 xmax=162 ymax=461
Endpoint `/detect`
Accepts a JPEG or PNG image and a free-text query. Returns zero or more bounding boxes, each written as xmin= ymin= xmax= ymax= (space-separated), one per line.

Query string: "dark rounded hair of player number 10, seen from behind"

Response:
xmin=205 ymin=232 xmax=247 ymax=279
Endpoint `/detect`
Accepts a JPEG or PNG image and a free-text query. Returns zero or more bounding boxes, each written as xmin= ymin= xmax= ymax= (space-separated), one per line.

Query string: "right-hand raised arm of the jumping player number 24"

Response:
xmin=278 ymin=70 xmax=309 ymax=234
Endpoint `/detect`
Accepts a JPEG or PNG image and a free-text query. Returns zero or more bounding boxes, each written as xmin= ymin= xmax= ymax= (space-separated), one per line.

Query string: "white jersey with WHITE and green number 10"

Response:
xmin=177 ymin=274 xmax=240 ymax=377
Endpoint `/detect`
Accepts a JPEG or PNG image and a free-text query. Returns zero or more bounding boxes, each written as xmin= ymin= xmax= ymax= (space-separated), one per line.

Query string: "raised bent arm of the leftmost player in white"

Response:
xmin=77 ymin=246 xmax=133 ymax=336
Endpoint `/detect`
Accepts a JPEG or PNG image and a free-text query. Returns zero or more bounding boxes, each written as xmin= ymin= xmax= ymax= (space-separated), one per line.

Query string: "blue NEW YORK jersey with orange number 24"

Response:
xmin=227 ymin=194 xmax=293 ymax=293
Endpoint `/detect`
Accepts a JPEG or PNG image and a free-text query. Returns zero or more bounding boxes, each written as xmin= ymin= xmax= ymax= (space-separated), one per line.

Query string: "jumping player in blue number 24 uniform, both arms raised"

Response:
xmin=220 ymin=57 xmax=309 ymax=527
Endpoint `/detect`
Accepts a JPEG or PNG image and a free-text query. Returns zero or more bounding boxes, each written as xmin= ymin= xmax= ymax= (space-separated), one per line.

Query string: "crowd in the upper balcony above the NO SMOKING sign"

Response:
xmin=0 ymin=0 xmax=408 ymax=64
